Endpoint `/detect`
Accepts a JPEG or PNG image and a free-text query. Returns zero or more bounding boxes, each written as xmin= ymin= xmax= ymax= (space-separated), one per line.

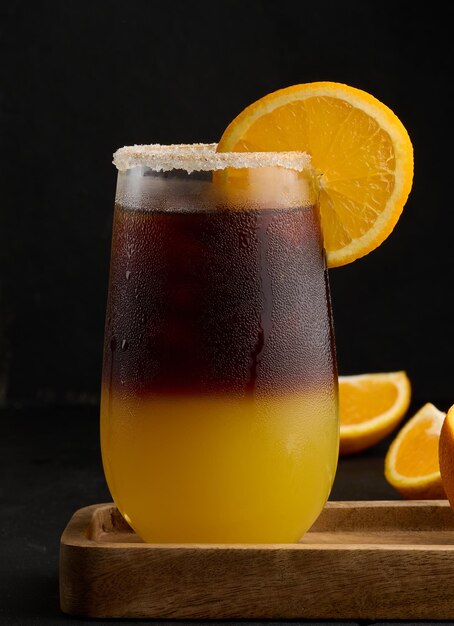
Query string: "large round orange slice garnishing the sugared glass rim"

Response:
xmin=217 ymin=82 xmax=413 ymax=267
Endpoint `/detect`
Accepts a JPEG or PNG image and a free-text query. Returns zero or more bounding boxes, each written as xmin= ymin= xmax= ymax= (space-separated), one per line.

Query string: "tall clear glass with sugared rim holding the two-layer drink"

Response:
xmin=101 ymin=145 xmax=339 ymax=543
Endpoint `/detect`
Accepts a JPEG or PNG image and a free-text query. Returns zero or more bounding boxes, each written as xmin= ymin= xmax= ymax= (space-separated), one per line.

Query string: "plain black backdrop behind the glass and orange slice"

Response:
xmin=0 ymin=0 xmax=454 ymax=410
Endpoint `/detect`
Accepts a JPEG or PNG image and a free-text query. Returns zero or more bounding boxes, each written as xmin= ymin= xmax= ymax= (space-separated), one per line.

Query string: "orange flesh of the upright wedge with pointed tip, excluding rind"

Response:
xmin=395 ymin=419 xmax=439 ymax=477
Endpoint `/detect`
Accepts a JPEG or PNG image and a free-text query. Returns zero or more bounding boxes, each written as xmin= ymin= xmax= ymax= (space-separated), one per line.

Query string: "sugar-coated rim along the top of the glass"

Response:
xmin=112 ymin=143 xmax=311 ymax=174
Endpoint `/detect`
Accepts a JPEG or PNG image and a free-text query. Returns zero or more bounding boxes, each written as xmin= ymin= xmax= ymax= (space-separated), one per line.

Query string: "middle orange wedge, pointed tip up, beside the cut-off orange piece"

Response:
xmin=385 ymin=402 xmax=446 ymax=500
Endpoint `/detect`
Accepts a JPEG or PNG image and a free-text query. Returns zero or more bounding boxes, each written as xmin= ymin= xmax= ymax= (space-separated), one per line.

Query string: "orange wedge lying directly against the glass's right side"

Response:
xmin=339 ymin=371 xmax=411 ymax=455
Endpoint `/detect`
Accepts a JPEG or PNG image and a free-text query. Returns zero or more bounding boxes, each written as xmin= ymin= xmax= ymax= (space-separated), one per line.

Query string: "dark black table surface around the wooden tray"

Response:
xmin=0 ymin=400 xmax=451 ymax=626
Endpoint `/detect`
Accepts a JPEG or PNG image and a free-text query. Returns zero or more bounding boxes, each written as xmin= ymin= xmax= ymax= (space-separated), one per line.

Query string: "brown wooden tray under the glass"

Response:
xmin=60 ymin=500 xmax=454 ymax=619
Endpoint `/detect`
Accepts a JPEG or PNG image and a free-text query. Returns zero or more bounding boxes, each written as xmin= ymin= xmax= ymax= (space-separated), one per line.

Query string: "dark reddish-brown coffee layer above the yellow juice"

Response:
xmin=103 ymin=205 xmax=335 ymax=395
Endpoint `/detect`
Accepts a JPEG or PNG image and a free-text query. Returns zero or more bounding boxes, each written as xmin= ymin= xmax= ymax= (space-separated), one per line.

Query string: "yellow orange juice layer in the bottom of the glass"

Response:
xmin=101 ymin=387 xmax=338 ymax=543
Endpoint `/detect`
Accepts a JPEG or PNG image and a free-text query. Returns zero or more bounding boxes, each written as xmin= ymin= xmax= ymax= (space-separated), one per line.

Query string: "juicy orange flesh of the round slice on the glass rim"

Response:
xmin=229 ymin=96 xmax=395 ymax=250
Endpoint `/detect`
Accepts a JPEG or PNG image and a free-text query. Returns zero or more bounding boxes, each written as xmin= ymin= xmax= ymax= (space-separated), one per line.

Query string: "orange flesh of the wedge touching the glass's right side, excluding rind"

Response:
xmin=339 ymin=384 xmax=398 ymax=425
